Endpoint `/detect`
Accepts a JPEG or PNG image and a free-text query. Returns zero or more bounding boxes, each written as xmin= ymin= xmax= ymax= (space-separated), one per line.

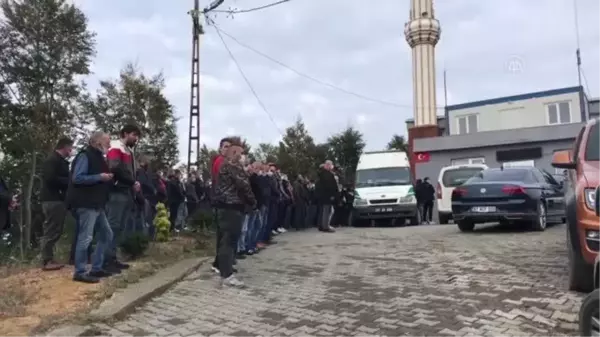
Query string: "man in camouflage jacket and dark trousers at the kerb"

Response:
xmin=214 ymin=137 xmax=256 ymax=287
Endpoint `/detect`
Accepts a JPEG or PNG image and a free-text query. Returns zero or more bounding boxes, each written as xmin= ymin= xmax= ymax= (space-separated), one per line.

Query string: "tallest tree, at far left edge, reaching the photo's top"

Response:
xmin=0 ymin=0 xmax=94 ymax=247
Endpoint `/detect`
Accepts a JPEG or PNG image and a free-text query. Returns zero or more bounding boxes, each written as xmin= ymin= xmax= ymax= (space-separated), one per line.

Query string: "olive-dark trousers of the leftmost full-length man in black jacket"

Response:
xmin=41 ymin=201 xmax=67 ymax=264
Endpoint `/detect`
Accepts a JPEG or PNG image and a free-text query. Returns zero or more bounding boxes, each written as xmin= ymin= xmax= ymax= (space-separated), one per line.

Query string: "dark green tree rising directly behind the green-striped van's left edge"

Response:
xmin=327 ymin=127 xmax=365 ymax=181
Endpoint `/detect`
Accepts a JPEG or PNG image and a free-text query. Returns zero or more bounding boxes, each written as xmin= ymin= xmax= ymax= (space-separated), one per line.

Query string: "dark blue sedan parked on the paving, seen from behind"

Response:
xmin=452 ymin=167 xmax=565 ymax=232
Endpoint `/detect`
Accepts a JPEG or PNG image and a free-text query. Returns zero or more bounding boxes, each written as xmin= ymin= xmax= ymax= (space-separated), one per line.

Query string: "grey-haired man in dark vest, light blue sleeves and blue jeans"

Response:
xmin=67 ymin=132 xmax=113 ymax=283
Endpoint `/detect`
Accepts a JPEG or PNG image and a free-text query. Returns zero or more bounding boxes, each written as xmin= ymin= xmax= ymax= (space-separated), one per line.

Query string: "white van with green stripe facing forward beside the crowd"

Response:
xmin=351 ymin=151 xmax=421 ymax=225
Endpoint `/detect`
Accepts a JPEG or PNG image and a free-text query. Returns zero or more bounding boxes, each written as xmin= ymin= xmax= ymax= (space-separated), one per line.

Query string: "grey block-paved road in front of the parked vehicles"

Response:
xmin=91 ymin=225 xmax=581 ymax=337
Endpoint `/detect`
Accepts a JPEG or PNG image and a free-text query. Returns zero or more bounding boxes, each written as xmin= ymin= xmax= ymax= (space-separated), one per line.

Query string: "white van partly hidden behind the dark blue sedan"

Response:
xmin=436 ymin=164 xmax=488 ymax=224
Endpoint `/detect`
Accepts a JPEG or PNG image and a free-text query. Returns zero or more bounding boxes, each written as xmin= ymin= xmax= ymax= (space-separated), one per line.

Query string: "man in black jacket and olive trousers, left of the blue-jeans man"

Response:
xmin=40 ymin=138 xmax=73 ymax=270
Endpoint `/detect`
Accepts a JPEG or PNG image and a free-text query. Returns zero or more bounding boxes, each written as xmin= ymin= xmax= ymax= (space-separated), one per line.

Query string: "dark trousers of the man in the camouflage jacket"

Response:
xmin=217 ymin=209 xmax=245 ymax=278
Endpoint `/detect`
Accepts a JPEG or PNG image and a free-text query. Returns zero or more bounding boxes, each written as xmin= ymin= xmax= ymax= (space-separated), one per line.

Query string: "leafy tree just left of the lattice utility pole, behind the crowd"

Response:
xmin=91 ymin=63 xmax=179 ymax=169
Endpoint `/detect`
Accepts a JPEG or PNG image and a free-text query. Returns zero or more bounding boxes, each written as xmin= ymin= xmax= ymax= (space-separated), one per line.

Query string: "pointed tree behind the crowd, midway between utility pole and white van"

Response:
xmin=277 ymin=119 xmax=315 ymax=177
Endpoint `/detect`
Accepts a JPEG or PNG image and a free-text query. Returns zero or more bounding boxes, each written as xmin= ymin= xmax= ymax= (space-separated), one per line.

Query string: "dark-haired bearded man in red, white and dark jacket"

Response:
xmin=105 ymin=125 xmax=141 ymax=273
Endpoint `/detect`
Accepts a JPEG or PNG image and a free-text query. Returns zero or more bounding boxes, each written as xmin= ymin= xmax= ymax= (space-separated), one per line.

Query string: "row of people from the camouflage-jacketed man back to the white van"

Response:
xmin=211 ymin=137 xmax=353 ymax=287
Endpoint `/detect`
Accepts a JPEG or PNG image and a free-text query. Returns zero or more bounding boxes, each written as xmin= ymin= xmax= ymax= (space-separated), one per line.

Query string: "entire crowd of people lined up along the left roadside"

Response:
xmin=0 ymin=125 xmax=354 ymax=286
